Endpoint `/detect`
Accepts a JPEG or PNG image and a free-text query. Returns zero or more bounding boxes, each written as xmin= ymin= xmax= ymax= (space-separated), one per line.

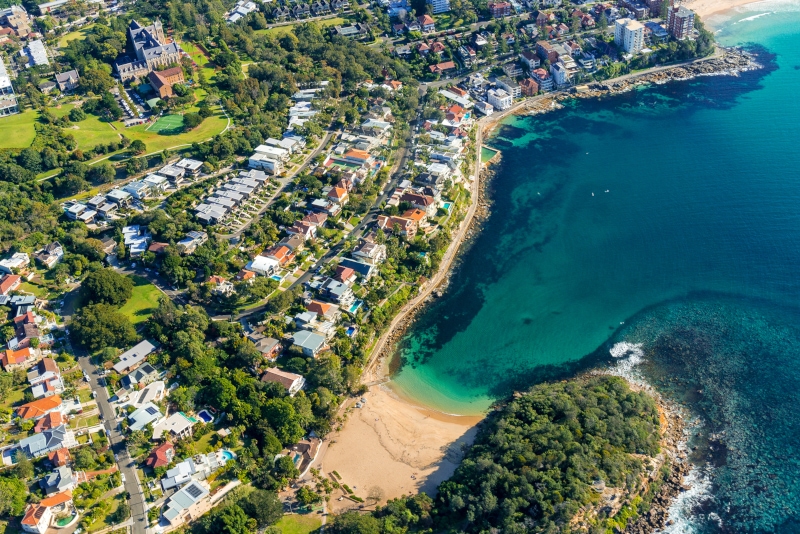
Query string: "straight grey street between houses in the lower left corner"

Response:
xmin=76 ymin=350 xmax=148 ymax=534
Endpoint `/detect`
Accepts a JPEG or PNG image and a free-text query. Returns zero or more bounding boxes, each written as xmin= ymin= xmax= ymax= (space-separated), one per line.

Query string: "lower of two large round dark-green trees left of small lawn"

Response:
xmin=70 ymin=303 xmax=136 ymax=351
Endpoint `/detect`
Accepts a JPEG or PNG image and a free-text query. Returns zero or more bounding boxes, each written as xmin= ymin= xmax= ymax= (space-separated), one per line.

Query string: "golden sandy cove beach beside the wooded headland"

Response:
xmin=323 ymin=386 xmax=481 ymax=513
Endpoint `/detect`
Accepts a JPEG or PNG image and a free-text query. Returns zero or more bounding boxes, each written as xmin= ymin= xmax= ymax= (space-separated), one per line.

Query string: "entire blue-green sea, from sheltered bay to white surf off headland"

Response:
xmin=390 ymin=0 xmax=800 ymax=533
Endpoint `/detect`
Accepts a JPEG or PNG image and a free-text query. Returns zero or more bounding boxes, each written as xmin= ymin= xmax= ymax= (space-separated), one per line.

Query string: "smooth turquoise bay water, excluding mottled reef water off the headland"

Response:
xmin=392 ymin=4 xmax=800 ymax=414
